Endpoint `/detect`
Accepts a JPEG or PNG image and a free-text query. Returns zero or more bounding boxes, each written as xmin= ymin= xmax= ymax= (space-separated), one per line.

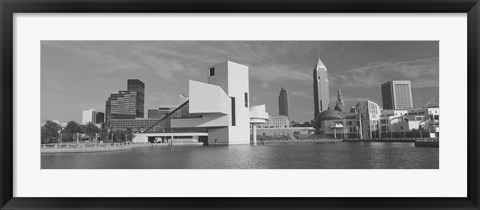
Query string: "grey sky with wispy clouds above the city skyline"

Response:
xmin=41 ymin=41 xmax=439 ymax=122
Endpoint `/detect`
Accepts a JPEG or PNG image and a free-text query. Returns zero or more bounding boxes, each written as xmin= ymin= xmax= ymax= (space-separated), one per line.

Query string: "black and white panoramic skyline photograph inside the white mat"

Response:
xmin=40 ymin=40 xmax=440 ymax=169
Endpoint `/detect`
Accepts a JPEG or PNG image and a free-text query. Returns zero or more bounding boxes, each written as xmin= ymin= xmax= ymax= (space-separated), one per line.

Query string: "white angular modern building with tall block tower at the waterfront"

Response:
xmin=134 ymin=61 xmax=268 ymax=145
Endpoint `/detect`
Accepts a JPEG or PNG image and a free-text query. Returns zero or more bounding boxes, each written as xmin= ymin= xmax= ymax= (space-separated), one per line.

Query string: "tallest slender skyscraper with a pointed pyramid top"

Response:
xmin=313 ymin=58 xmax=330 ymax=119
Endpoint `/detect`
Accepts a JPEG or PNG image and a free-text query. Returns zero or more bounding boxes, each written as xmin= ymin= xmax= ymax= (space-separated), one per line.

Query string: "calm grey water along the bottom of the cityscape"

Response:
xmin=42 ymin=142 xmax=439 ymax=169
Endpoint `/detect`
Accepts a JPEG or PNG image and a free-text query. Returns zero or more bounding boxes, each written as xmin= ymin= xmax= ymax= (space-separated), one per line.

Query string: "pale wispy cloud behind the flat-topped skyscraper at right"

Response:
xmin=329 ymin=58 xmax=439 ymax=88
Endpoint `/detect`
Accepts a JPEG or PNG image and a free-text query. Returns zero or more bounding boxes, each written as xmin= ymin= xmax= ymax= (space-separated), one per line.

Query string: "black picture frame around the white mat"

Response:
xmin=0 ymin=0 xmax=480 ymax=209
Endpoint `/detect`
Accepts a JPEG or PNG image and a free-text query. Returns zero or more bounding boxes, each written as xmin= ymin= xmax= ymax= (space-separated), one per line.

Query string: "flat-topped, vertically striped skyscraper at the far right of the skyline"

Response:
xmin=382 ymin=80 xmax=413 ymax=109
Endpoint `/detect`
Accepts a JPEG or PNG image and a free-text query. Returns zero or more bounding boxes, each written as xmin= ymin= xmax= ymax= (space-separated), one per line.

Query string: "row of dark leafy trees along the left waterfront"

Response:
xmin=41 ymin=120 xmax=134 ymax=144
